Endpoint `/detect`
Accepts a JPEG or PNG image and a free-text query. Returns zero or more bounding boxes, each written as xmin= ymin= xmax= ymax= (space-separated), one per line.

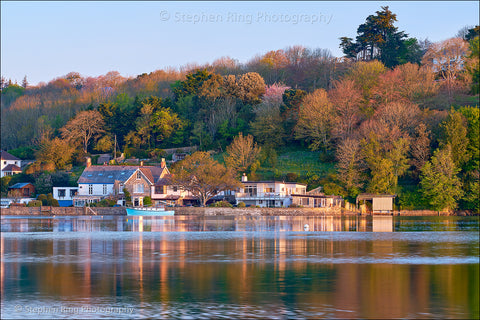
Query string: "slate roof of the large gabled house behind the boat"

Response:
xmin=78 ymin=166 xmax=164 ymax=184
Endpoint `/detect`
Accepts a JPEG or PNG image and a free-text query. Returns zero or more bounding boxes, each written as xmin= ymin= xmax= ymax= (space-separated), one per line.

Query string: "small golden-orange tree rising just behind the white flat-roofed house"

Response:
xmin=224 ymin=132 xmax=261 ymax=172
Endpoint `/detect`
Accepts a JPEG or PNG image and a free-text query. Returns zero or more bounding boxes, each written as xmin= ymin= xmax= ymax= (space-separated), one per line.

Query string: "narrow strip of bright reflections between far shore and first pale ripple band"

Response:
xmin=2 ymin=216 xmax=479 ymax=232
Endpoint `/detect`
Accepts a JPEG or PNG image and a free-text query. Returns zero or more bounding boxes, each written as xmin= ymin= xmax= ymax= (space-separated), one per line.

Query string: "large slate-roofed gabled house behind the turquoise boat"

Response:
xmin=73 ymin=159 xmax=166 ymax=206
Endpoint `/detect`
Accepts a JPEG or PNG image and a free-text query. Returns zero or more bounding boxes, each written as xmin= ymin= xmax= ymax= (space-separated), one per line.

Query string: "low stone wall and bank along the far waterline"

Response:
xmin=1 ymin=206 xmax=478 ymax=216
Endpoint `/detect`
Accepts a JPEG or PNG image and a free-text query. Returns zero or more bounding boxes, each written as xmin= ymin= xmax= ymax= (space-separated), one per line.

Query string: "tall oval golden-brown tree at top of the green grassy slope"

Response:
xmin=295 ymin=89 xmax=333 ymax=152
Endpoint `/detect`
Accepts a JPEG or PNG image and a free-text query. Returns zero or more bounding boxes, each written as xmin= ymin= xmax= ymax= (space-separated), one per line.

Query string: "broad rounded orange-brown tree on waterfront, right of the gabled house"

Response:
xmin=172 ymin=151 xmax=240 ymax=206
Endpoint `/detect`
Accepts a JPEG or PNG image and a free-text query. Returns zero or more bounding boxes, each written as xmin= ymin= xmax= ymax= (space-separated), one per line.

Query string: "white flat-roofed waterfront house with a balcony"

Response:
xmin=235 ymin=174 xmax=307 ymax=207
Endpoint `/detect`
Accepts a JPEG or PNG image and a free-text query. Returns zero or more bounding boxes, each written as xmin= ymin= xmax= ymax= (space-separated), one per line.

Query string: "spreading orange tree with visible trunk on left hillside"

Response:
xmin=60 ymin=110 xmax=105 ymax=153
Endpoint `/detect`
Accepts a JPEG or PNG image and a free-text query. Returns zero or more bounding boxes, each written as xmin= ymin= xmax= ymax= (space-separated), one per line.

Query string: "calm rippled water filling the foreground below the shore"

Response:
xmin=0 ymin=216 xmax=480 ymax=319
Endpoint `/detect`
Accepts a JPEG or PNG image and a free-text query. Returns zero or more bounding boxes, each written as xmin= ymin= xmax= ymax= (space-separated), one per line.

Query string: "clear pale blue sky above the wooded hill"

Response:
xmin=0 ymin=1 xmax=479 ymax=85
